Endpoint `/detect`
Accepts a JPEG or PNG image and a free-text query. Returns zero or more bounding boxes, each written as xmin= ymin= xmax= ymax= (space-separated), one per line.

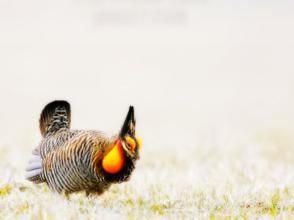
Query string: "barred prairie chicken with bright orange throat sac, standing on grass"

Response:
xmin=26 ymin=101 xmax=140 ymax=194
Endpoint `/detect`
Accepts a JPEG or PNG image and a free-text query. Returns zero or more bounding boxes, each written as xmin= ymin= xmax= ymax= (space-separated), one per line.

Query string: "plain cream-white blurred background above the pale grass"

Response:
xmin=0 ymin=0 xmax=294 ymax=165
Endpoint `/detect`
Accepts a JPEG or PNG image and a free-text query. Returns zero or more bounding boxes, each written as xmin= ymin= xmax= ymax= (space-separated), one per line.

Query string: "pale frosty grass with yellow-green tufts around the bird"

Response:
xmin=0 ymin=137 xmax=294 ymax=219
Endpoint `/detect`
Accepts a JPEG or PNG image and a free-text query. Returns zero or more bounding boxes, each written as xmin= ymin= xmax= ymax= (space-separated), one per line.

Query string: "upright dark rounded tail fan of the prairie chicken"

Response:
xmin=40 ymin=100 xmax=71 ymax=136
